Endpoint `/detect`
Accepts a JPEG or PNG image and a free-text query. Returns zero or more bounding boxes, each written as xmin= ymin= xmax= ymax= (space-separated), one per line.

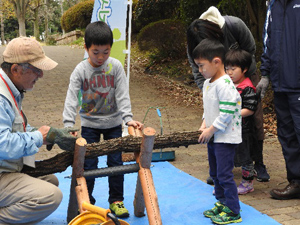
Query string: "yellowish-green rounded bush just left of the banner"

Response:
xmin=61 ymin=0 xmax=94 ymax=32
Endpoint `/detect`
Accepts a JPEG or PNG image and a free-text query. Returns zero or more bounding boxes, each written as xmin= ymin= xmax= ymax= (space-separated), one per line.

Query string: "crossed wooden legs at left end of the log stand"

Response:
xmin=67 ymin=138 xmax=90 ymax=223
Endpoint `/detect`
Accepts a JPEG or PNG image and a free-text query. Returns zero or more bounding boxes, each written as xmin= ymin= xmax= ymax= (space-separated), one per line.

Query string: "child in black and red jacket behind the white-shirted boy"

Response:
xmin=225 ymin=49 xmax=258 ymax=195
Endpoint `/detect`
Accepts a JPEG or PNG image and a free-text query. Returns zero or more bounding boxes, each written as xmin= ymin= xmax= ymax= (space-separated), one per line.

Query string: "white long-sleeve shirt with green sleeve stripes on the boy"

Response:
xmin=203 ymin=74 xmax=242 ymax=144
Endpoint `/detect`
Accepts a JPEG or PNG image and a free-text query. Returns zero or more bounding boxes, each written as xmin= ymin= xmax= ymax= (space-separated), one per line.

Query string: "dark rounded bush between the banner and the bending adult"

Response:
xmin=137 ymin=19 xmax=186 ymax=59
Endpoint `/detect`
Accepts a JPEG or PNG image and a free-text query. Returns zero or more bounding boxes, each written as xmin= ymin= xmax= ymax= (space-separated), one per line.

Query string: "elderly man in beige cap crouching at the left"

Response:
xmin=0 ymin=37 xmax=75 ymax=224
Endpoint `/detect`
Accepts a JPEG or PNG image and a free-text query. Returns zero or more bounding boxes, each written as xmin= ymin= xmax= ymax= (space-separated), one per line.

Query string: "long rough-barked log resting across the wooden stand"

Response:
xmin=22 ymin=131 xmax=200 ymax=177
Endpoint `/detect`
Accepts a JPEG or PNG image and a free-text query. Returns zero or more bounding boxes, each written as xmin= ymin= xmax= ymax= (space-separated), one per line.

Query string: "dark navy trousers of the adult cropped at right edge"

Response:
xmin=274 ymin=92 xmax=300 ymax=184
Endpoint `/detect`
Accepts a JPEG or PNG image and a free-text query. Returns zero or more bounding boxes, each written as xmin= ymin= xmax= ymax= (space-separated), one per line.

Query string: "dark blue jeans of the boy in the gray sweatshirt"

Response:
xmin=81 ymin=125 xmax=124 ymax=204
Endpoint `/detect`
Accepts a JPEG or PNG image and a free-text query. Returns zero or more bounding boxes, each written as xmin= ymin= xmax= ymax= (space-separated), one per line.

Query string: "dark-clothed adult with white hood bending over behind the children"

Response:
xmin=187 ymin=6 xmax=270 ymax=184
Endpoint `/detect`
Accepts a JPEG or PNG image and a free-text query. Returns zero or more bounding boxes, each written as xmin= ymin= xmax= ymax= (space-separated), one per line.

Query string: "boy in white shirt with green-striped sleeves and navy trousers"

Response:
xmin=193 ymin=39 xmax=242 ymax=224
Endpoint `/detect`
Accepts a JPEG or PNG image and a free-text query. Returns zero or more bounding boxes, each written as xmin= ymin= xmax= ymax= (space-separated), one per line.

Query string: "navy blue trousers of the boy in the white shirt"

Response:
xmin=207 ymin=143 xmax=240 ymax=214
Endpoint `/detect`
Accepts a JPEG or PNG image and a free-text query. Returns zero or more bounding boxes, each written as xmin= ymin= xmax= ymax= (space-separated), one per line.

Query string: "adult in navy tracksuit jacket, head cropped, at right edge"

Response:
xmin=257 ymin=0 xmax=300 ymax=199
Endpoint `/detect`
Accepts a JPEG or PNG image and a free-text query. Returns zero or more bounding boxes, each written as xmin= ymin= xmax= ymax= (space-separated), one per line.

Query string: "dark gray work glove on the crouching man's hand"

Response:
xmin=46 ymin=127 xmax=79 ymax=152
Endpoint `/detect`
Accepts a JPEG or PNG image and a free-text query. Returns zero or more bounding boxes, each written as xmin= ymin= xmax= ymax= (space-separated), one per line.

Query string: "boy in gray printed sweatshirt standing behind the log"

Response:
xmin=63 ymin=21 xmax=142 ymax=217
